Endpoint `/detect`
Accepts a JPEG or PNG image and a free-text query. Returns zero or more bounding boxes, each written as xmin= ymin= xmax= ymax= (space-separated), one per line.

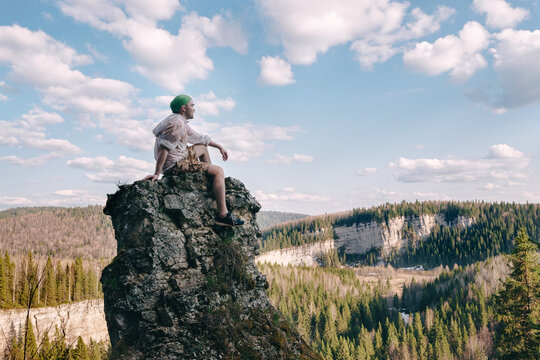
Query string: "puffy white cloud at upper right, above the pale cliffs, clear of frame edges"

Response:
xmin=403 ymin=21 xmax=490 ymax=81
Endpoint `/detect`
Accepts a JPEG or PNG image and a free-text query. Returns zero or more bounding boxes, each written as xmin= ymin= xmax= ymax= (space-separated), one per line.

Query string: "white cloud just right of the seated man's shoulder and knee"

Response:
xmin=211 ymin=123 xmax=300 ymax=161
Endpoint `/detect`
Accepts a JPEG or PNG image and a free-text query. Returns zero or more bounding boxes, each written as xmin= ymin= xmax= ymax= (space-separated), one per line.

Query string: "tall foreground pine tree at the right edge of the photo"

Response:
xmin=496 ymin=230 xmax=540 ymax=359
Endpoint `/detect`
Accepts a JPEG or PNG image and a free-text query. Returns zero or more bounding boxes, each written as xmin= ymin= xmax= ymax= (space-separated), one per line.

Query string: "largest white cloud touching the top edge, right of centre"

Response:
xmin=258 ymin=0 xmax=455 ymax=69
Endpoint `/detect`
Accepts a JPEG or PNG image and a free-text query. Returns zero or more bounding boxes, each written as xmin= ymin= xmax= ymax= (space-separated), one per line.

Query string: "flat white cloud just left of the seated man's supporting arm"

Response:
xmin=67 ymin=155 xmax=154 ymax=183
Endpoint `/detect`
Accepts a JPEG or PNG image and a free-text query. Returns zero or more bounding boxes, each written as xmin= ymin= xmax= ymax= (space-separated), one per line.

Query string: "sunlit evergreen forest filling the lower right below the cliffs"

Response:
xmin=259 ymin=232 xmax=540 ymax=360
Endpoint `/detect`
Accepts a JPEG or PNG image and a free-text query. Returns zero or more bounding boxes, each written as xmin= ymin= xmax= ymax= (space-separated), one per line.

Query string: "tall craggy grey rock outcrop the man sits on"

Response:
xmin=101 ymin=174 xmax=319 ymax=359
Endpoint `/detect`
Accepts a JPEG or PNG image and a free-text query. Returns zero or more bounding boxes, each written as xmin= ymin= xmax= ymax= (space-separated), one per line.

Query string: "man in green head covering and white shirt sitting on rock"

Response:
xmin=143 ymin=95 xmax=244 ymax=226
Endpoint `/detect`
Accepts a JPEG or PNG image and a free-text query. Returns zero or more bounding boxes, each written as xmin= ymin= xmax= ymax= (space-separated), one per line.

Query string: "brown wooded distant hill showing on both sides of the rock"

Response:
xmin=0 ymin=205 xmax=307 ymax=260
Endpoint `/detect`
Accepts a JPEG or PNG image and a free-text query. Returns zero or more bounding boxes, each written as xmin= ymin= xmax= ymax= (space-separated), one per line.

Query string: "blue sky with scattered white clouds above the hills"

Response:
xmin=0 ymin=0 xmax=540 ymax=215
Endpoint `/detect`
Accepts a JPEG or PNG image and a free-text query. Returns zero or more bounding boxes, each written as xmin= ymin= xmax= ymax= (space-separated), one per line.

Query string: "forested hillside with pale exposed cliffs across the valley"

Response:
xmin=259 ymin=202 xmax=540 ymax=267
